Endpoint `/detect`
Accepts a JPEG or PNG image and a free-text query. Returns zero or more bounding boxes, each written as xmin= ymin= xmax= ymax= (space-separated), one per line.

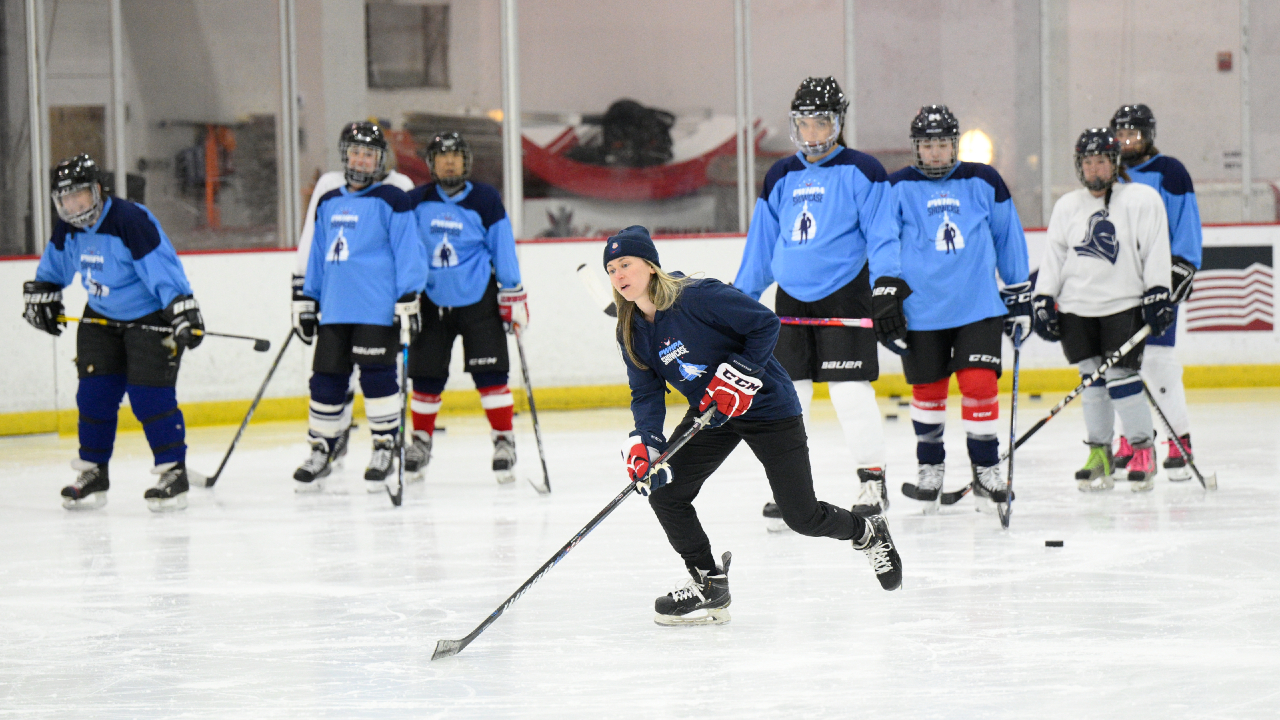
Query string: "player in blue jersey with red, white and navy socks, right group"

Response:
xmin=872 ymin=105 xmax=1032 ymax=512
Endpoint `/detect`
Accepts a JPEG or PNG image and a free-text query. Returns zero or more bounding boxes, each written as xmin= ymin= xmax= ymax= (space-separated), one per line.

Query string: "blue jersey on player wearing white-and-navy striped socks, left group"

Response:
xmin=302 ymin=183 xmax=428 ymax=325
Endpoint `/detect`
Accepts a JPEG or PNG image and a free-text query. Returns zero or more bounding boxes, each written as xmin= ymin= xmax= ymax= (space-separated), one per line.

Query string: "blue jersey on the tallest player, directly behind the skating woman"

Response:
xmin=733 ymin=147 xmax=893 ymax=302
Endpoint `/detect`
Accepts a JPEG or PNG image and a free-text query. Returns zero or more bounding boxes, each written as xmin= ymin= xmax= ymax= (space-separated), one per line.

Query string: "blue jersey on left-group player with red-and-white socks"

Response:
xmin=408 ymin=182 xmax=520 ymax=307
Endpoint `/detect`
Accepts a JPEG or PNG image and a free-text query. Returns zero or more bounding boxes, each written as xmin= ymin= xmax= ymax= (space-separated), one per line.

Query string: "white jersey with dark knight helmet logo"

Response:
xmin=1036 ymin=183 xmax=1170 ymax=318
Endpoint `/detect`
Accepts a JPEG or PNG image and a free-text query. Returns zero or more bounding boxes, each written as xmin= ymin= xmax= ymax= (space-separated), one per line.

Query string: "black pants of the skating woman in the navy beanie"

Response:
xmin=649 ymin=407 xmax=863 ymax=570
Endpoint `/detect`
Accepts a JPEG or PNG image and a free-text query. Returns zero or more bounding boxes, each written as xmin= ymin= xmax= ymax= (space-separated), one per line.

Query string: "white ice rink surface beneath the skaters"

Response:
xmin=0 ymin=389 xmax=1280 ymax=720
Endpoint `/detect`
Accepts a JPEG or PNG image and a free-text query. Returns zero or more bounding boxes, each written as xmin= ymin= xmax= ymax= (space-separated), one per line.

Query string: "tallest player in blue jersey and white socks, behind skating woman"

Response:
xmin=733 ymin=77 xmax=893 ymax=523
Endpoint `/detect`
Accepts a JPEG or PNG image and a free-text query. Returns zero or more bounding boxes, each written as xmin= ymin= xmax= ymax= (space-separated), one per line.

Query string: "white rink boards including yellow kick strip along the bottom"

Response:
xmin=0 ymin=224 xmax=1280 ymax=434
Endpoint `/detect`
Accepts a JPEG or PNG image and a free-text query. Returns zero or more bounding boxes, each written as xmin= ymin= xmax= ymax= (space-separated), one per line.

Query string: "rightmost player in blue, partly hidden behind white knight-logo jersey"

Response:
xmin=1111 ymin=104 xmax=1203 ymax=482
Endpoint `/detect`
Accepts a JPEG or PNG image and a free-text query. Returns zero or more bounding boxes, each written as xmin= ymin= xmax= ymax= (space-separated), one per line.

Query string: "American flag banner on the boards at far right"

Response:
xmin=1184 ymin=245 xmax=1275 ymax=333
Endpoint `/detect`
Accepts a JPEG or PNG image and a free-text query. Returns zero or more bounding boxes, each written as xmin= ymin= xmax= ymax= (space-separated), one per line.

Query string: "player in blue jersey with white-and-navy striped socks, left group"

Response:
xmin=293 ymin=122 xmax=426 ymax=492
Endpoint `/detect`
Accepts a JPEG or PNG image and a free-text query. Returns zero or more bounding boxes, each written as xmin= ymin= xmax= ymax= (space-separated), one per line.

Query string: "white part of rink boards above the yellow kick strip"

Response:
xmin=0 ymin=225 xmax=1280 ymax=413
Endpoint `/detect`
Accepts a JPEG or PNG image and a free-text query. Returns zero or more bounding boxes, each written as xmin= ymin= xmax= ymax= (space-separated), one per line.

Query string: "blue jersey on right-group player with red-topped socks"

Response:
xmin=872 ymin=163 xmax=1028 ymax=331
